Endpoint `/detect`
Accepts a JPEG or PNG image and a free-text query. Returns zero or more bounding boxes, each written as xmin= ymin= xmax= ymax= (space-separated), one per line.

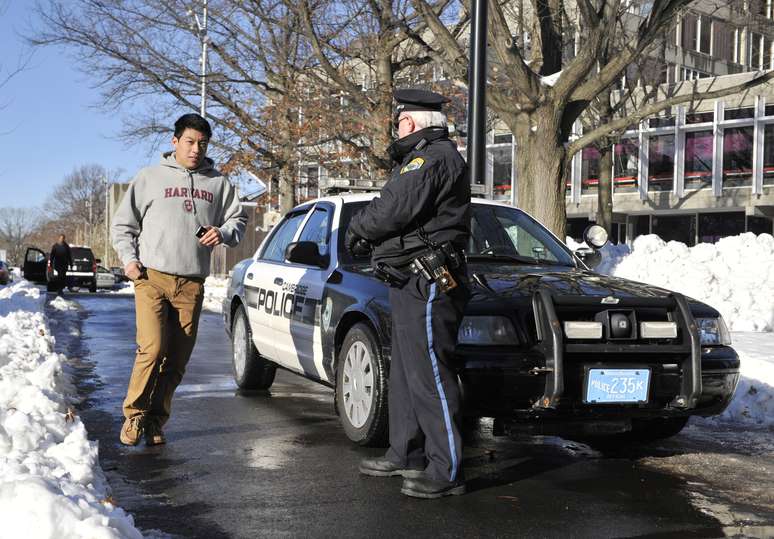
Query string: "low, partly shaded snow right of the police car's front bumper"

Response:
xmin=693 ymin=333 xmax=774 ymax=428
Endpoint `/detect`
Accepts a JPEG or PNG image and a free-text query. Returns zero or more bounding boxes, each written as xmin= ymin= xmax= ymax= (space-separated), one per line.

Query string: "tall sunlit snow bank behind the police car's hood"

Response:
xmin=612 ymin=232 xmax=774 ymax=331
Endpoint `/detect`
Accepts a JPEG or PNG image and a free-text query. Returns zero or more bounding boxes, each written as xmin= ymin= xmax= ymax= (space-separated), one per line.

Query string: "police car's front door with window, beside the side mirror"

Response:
xmin=272 ymin=202 xmax=335 ymax=381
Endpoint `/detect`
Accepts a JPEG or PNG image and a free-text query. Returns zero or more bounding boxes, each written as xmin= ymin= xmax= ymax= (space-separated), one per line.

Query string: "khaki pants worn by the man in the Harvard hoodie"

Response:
xmin=124 ymin=269 xmax=204 ymax=425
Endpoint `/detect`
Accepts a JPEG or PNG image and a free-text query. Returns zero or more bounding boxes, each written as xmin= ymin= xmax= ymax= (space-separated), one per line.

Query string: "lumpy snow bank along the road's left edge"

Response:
xmin=0 ymin=281 xmax=142 ymax=538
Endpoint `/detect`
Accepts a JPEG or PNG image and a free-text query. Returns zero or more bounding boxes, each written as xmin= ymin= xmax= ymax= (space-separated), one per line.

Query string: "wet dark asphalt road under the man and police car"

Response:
xmin=48 ymin=294 xmax=774 ymax=538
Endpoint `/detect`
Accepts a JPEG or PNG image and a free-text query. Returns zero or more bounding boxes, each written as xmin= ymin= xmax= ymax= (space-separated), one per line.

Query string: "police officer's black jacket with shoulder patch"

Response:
xmin=349 ymin=127 xmax=470 ymax=268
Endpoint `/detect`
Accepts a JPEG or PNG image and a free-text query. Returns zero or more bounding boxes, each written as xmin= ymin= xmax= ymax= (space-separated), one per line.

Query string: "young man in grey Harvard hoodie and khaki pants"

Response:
xmin=112 ymin=114 xmax=247 ymax=445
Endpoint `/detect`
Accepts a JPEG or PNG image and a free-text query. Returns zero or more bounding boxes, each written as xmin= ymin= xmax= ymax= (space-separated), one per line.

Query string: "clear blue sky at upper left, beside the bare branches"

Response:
xmin=0 ymin=4 xmax=158 ymax=211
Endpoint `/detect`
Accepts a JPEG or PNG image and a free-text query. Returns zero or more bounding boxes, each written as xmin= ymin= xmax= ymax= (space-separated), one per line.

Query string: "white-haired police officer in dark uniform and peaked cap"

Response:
xmin=346 ymin=90 xmax=470 ymax=498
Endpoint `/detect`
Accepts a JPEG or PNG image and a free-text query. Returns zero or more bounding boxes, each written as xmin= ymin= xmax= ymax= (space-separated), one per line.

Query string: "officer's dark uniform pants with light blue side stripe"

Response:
xmin=386 ymin=275 xmax=470 ymax=481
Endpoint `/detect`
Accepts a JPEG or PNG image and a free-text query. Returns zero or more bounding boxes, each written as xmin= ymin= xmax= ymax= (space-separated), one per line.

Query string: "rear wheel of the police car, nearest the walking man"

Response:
xmin=231 ymin=306 xmax=277 ymax=389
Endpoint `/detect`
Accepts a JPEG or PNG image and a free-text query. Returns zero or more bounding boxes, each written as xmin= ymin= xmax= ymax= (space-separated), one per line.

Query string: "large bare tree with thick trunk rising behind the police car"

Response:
xmin=413 ymin=0 xmax=774 ymax=237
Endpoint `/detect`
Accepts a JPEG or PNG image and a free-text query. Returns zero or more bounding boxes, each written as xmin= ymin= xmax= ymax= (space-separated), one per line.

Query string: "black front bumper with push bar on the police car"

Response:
xmin=458 ymin=289 xmax=739 ymax=420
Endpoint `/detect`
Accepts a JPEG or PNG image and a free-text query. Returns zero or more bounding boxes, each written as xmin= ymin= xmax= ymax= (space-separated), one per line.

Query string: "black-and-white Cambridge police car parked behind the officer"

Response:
xmin=223 ymin=195 xmax=739 ymax=445
